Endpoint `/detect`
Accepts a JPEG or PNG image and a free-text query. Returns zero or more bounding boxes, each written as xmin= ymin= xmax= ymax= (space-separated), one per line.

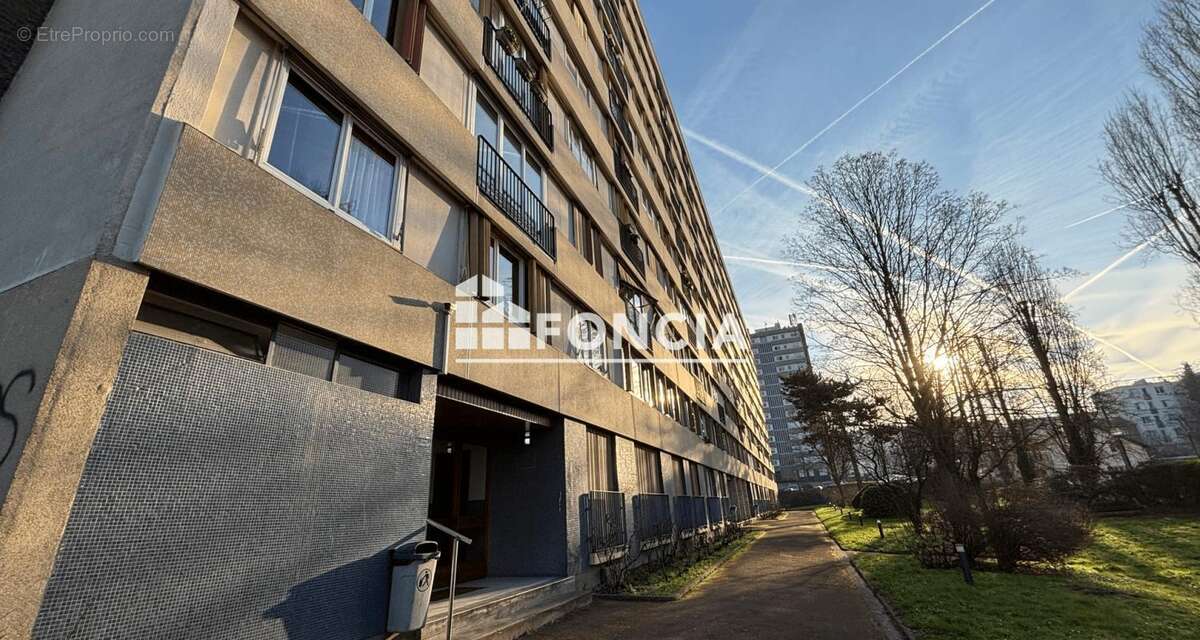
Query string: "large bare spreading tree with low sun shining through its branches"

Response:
xmin=791 ymin=152 xmax=1008 ymax=489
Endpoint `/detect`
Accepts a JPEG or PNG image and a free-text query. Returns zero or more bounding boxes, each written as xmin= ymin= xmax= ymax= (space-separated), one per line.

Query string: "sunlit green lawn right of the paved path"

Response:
xmin=849 ymin=510 xmax=1200 ymax=640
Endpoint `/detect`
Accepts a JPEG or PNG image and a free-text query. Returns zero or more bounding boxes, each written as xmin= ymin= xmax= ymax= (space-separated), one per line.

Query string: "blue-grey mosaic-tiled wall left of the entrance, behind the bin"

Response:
xmin=34 ymin=334 xmax=434 ymax=640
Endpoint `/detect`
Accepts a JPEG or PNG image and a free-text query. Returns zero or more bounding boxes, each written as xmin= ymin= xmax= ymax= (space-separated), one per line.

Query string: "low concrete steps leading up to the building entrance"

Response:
xmin=420 ymin=578 xmax=592 ymax=640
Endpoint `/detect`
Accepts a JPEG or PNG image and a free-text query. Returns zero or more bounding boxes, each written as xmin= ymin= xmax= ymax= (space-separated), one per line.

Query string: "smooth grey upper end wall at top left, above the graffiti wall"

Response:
xmin=0 ymin=0 xmax=198 ymax=291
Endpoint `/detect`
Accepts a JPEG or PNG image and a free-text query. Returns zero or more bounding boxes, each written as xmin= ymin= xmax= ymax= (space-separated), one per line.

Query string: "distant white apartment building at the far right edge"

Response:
xmin=1102 ymin=378 xmax=1195 ymax=457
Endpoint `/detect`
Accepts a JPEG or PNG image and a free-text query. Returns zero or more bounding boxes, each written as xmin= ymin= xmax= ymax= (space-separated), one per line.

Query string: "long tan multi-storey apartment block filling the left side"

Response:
xmin=0 ymin=0 xmax=776 ymax=639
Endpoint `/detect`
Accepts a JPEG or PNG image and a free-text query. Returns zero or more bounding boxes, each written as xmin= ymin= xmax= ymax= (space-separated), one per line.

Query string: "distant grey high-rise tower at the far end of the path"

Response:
xmin=750 ymin=316 xmax=830 ymax=491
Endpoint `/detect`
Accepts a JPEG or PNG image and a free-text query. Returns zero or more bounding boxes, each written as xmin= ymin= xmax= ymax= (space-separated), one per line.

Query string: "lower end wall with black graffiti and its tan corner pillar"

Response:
xmin=0 ymin=259 xmax=146 ymax=638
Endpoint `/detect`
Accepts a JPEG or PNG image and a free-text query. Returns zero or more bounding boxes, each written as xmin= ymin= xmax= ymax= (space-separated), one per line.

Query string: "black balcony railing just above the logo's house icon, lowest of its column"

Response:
xmin=475 ymin=136 xmax=558 ymax=258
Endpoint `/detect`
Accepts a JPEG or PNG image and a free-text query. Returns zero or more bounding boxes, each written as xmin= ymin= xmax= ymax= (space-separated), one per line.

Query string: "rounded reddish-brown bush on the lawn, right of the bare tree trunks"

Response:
xmin=983 ymin=488 xmax=1091 ymax=572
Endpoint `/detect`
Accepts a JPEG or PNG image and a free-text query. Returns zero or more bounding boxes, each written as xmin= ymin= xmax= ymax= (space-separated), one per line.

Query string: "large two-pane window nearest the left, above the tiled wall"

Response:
xmin=266 ymin=72 xmax=403 ymax=241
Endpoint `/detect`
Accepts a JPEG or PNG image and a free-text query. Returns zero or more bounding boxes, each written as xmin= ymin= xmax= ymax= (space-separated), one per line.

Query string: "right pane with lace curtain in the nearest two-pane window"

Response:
xmin=338 ymin=132 xmax=396 ymax=239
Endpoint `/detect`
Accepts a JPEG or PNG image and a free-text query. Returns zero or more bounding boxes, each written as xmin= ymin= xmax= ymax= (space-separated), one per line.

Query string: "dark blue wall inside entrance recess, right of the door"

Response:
xmin=487 ymin=429 xmax=566 ymax=575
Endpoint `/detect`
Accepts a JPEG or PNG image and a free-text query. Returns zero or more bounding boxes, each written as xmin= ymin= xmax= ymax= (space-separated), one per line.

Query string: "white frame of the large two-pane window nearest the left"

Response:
xmin=254 ymin=57 xmax=408 ymax=251
